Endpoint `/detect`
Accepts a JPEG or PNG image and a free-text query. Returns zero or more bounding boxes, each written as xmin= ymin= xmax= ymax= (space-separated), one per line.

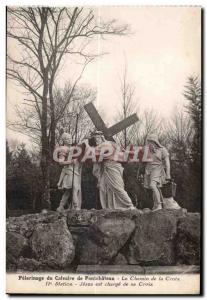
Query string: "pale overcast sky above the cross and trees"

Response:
xmin=7 ymin=6 xmax=201 ymax=144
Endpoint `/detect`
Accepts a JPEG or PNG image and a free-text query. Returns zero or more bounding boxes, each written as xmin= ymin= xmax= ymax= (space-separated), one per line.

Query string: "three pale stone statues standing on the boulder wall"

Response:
xmin=57 ymin=131 xmax=176 ymax=212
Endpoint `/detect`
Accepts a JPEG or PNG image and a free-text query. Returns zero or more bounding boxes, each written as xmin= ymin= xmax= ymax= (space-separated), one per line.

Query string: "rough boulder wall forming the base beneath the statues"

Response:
xmin=7 ymin=209 xmax=200 ymax=271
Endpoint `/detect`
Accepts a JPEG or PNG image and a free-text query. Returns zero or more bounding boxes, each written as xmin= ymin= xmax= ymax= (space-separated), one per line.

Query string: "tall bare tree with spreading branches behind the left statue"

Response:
xmin=7 ymin=7 xmax=128 ymax=208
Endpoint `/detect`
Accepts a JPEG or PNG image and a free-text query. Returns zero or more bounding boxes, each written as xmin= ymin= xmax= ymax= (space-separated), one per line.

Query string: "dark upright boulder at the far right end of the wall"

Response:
xmin=175 ymin=213 xmax=200 ymax=265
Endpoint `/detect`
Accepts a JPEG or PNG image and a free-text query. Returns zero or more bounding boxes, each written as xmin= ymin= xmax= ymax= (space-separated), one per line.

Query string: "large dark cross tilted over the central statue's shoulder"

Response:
xmin=84 ymin=102 xmax=139 ymax=141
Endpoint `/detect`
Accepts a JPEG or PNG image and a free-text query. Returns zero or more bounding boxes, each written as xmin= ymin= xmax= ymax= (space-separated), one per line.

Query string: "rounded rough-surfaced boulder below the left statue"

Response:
xmin=30 ymin=219 xmax=75 ymax=269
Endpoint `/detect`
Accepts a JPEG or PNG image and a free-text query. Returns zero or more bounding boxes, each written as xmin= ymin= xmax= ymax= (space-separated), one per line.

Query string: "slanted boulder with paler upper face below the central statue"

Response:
xmin=77 ymin=212 xmax=135 ymax=264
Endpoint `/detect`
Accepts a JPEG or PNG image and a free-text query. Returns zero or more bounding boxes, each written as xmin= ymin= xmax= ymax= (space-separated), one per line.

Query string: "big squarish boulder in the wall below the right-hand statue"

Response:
xmin=125 ymin=210 xmax=177 ymax=265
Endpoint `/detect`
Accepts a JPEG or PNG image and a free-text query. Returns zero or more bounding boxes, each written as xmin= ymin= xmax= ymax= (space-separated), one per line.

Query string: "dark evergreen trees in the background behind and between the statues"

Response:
xmin=6 ymin=77 xmax=202 ymax=214
